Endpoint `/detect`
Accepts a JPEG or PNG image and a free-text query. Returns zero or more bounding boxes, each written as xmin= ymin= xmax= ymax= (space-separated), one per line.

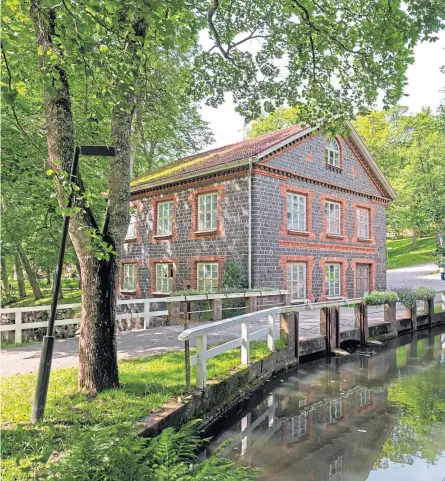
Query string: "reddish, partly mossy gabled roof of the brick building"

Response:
xmin=130 ymin=122 xmax=396 ymax=200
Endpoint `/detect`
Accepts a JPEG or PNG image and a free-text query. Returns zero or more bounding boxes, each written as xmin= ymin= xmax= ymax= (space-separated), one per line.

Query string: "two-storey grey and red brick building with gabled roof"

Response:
xmin=120 ymin=125 xmax=395 ymax=300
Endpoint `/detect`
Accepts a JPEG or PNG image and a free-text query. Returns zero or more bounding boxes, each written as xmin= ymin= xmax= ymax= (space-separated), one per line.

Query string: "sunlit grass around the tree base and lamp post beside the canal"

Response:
xmin=0 ymin=342 xmax=269 ymax=480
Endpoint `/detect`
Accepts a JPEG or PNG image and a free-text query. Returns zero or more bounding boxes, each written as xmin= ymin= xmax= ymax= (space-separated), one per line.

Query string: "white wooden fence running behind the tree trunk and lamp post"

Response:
xmin=0 ymin=298 xmax=168 ymax=344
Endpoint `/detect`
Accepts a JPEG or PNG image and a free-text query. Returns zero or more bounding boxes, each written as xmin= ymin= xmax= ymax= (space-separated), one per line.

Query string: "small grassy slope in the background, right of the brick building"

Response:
xmin=386 ymin=237 xmax=436 ymax=269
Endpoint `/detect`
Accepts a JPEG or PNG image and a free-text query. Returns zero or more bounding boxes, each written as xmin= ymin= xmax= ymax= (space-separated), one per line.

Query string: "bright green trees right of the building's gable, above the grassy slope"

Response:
xmin=354 ymin=107 xmax=445 ymax=234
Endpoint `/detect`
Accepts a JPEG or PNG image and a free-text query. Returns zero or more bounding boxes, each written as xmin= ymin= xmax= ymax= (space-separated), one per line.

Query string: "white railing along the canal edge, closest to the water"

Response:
xmin=178 ymin=298 xmax=362 ymax=389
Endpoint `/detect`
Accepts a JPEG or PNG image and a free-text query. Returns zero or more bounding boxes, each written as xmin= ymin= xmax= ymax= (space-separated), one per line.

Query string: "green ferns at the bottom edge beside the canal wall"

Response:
xmin=39 ymin=424 xmax=257 ymax=481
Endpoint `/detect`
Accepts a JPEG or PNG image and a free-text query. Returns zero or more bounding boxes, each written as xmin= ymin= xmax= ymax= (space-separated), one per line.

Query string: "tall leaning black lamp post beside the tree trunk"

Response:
xmin=31 ymin=145 xmax=116 ymax=422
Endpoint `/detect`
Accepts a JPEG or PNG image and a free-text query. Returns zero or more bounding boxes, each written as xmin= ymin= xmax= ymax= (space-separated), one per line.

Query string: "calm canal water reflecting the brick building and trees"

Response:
xmin=203 ymin=328 xmax=445 ymax=481
